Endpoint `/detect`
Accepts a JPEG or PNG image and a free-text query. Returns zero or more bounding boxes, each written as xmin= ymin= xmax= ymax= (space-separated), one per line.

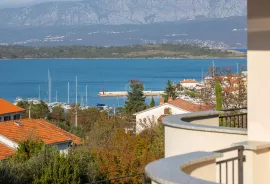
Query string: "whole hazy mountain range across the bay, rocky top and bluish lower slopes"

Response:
xmin=0 ymin=0 xmax=247 ymax=48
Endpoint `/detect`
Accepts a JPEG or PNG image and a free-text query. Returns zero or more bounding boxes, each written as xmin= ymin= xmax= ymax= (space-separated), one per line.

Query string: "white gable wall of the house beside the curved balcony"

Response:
xmin=136 ymin=104 xmax=188 ymax=134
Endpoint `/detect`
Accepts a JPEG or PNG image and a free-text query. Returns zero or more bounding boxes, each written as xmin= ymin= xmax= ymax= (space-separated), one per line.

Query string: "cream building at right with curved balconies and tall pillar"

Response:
xmin=145 ymin=0 xmax=270 ymax=184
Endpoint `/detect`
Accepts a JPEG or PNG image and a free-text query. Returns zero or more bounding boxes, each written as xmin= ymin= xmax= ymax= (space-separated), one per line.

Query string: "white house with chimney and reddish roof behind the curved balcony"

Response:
xmin=134 ymin=98 xmax=209 ymax=134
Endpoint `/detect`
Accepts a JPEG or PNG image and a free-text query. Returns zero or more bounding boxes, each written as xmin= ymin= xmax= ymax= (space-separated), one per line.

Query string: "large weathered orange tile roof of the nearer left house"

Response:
xmin=0 ymin=119 xmax=81 ymax=144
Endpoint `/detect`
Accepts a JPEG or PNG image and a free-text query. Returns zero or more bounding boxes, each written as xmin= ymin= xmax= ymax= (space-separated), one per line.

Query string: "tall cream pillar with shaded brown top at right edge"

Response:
xmin=248 ymin=0 xmax=270 ymax=141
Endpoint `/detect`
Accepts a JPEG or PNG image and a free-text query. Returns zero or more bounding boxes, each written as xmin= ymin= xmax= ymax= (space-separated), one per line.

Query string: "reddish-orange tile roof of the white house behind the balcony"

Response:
xmin=168 ymin=98 xmax=211 ymax=112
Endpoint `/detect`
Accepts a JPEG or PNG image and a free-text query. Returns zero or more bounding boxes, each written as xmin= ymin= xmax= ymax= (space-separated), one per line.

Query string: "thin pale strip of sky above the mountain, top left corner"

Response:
xmin=0 ymin=0 xmax=75 ymax=8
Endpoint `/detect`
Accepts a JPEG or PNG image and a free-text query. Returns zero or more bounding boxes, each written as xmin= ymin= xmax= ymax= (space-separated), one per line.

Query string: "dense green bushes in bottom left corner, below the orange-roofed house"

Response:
xmin=0 ymin=141 xmax=99 ymax=184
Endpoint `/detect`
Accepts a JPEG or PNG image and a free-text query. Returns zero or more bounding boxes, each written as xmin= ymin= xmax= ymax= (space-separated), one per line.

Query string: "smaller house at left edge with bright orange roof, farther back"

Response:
xmin=0 ymin=98 xmax=25 ymax=122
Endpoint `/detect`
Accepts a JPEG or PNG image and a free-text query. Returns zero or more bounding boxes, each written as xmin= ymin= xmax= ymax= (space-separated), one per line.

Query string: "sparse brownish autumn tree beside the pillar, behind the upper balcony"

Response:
xmin=199 ymin=66 xmax=247 ymax=109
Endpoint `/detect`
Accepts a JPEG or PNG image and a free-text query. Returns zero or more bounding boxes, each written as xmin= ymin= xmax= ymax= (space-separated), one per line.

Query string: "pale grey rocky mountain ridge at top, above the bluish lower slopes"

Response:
xmin=0 ymin=0 xmax=247 ymax=27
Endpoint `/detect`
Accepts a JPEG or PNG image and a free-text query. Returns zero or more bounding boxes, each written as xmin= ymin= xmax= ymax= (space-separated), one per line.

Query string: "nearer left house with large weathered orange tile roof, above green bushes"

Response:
xmin=0 ymin=119 xmax=81 ymax=160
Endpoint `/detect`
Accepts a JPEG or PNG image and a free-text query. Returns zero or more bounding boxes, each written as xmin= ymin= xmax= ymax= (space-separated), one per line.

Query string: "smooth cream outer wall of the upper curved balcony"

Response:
xmin=165 ymin=126 xmax=248 ymax=157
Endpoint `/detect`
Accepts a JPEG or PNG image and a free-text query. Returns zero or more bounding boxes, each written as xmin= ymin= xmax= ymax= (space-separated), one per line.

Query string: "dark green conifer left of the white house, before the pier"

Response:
xmin=125 ymin=80 xmax=147 ymax=116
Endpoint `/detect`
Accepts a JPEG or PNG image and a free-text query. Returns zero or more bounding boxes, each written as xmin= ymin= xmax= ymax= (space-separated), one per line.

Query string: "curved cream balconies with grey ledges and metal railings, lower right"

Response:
xmin=145 ymin=109 xmax=270 ymax=184
